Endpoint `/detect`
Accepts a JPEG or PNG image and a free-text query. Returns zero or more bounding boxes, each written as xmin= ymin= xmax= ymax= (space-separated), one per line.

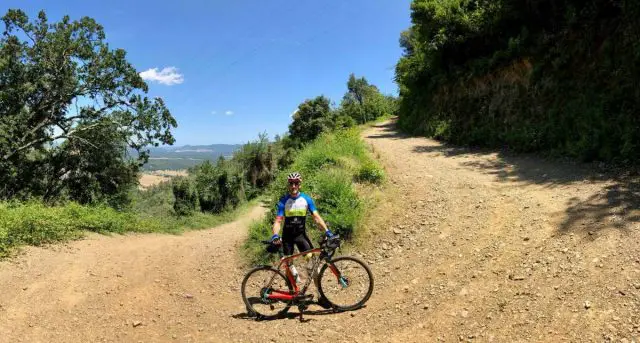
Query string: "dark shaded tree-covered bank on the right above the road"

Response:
xmin=396 ymin=0 xmax=640 ymax=163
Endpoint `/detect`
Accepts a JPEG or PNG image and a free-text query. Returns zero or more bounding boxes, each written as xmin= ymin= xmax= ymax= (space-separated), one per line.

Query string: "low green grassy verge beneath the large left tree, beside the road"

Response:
xmin=0 ymin=183 xmax=257 ymax=257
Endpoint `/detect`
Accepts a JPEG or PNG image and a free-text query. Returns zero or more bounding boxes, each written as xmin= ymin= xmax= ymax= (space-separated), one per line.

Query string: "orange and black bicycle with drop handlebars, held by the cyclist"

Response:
xmin=241 ymin=235 xmax=373 ymax=321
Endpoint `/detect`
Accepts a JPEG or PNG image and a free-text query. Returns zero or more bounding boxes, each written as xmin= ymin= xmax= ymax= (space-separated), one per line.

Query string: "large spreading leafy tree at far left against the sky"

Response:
xmin=0 ymin=10 xmax=177 ymax=202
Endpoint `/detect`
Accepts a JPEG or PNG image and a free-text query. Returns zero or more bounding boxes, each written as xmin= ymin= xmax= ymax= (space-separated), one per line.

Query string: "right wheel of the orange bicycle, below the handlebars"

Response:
xmin=318 ymin=256 xmax=373 ymax=311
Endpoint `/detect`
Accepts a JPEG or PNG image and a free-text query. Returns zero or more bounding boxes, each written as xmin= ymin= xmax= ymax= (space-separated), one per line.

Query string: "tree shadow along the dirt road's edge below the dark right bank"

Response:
xmin=376 ymin=122 xmax=640 ymax=234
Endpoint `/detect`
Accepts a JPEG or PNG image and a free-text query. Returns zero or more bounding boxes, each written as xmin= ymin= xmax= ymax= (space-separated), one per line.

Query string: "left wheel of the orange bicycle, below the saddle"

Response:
xmin=241 ymin=266 xmax=293 ymax=319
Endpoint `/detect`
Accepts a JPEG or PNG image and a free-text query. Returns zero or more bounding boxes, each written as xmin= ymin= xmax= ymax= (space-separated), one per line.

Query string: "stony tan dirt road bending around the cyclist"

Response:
xmin=0 ymin=120 xmax=640 ymax=342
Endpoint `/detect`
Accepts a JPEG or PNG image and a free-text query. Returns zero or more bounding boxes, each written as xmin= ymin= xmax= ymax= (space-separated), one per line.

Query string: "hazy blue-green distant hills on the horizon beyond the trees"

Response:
xmin=134 ymin=144 xmax=242 ymax=171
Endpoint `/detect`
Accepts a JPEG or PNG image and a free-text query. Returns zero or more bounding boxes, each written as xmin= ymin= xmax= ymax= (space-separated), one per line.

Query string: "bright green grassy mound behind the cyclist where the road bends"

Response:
xmin=243 ymin=128 xmax=384 ymax=264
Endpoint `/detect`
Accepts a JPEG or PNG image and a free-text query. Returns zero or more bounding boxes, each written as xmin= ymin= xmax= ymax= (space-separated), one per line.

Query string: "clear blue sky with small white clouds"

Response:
xmin=0 ymin=0 xmax=411 ymax=145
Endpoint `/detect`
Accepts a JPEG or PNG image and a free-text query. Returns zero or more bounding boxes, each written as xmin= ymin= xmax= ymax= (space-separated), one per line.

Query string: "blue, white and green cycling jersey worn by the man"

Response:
xmin=277 ymin=193 xmax=316 ymax=236
